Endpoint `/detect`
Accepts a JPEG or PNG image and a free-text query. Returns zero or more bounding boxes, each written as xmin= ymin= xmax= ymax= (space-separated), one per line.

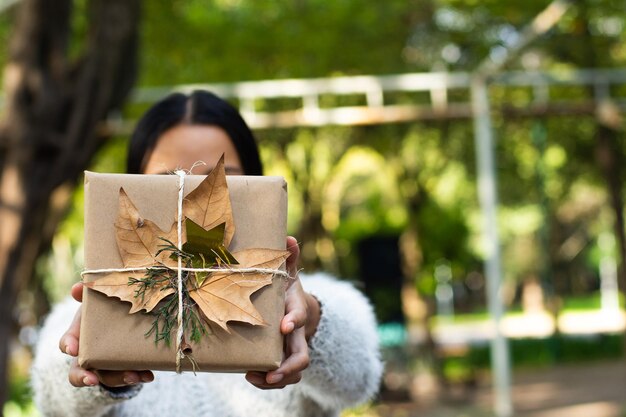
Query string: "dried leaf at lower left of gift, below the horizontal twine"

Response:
xmin=84 ymin=271 xmax=175 ymax=314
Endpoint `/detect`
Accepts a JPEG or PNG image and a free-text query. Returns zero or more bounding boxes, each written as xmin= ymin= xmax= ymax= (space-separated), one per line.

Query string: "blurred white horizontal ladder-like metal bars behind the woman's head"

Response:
xmin=125 ymin=69 xmax=626 ymax=129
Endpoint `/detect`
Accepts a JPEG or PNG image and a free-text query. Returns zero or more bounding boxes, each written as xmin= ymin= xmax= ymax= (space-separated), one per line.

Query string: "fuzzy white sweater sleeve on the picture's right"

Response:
xmin=301 ymin=274 xmax=383 ymax=410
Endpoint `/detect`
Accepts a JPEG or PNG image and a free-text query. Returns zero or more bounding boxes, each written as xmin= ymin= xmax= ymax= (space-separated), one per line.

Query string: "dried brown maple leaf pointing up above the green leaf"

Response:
xmin=183 ymin=155 xmax=235 ymax=247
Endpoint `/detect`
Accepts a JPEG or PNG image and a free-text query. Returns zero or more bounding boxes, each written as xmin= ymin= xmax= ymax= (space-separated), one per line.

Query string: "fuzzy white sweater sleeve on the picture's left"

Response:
xmin=31 ymin=299 xmax=141 ymax=417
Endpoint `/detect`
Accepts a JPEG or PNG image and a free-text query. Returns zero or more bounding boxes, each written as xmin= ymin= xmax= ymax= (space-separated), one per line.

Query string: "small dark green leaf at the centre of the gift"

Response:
xmin=183 ymin=219 xmax=239 ymax=285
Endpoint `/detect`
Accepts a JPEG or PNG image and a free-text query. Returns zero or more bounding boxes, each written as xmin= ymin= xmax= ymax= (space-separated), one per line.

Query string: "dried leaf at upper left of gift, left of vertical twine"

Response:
xmin=115 ymin=188 xmax=177 ymax=268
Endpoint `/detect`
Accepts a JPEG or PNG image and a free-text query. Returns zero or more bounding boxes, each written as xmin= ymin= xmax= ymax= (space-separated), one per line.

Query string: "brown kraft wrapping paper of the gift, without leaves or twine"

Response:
xmin=78 ymin=172 xmax=287 ymax=372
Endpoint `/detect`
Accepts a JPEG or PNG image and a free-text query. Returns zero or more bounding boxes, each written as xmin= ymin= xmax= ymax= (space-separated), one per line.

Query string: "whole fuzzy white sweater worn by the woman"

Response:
xmin=32 ymin=274 xmax=382 ymax=417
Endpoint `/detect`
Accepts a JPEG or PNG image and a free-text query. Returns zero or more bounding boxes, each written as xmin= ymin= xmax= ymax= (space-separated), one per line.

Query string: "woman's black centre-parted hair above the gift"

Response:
xmin=126 ymin=90 xmax=263 ymax=175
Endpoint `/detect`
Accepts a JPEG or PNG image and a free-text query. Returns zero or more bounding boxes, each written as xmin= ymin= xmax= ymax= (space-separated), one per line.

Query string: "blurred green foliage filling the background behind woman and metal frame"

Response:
xmin=0 ymin=0 xmax=626 ymax=410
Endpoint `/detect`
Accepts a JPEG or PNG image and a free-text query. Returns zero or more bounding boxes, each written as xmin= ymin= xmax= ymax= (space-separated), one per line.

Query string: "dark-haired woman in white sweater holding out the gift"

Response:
xmin=32 ymin=91 xmax=382 ymax=417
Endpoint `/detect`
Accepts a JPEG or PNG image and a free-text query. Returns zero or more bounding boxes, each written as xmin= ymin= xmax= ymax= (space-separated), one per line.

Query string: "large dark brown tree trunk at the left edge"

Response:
xmin=0 ymin=0 xmax=139 ymax=410
